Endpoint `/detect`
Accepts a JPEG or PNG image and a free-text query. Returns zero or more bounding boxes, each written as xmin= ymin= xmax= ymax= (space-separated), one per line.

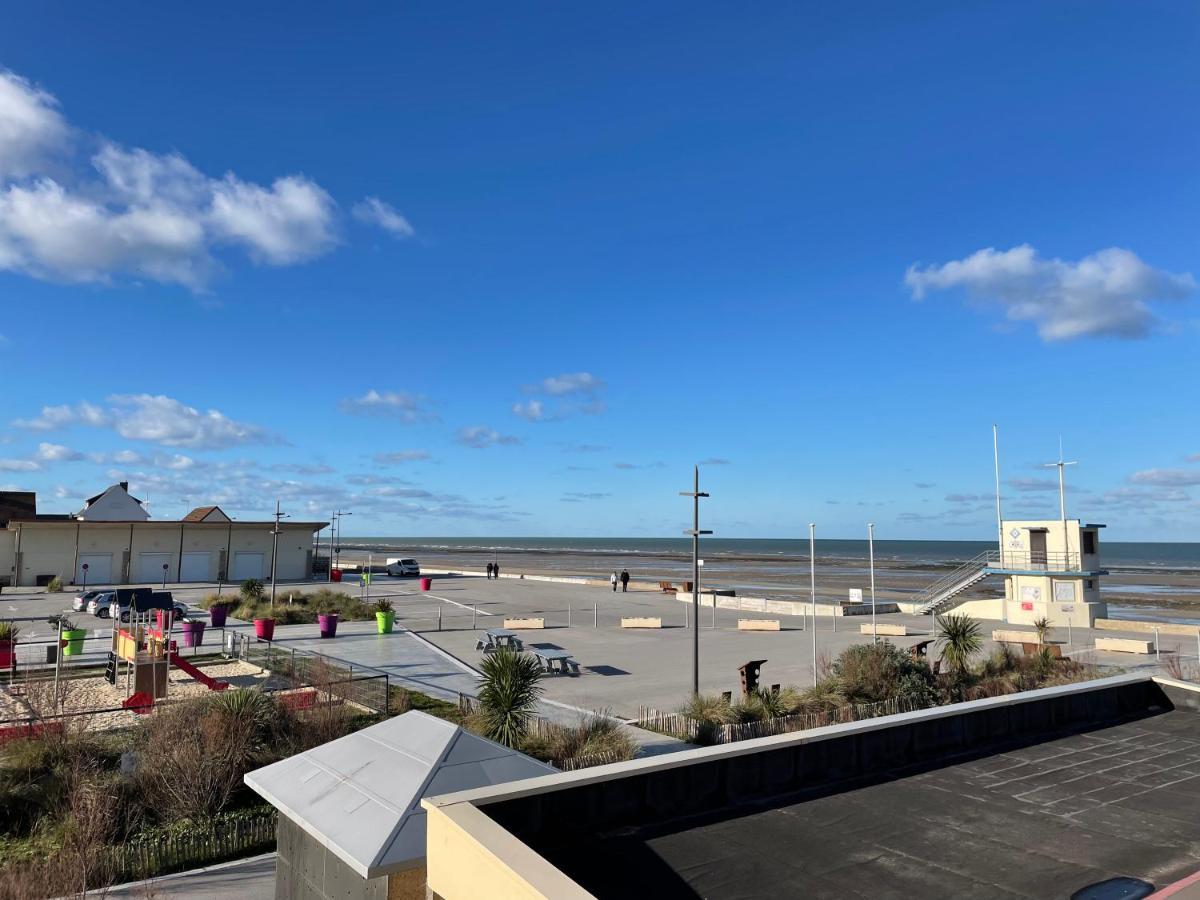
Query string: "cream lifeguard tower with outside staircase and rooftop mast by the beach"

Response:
xmin=917 ymin=444 xmax=1108 ymax=628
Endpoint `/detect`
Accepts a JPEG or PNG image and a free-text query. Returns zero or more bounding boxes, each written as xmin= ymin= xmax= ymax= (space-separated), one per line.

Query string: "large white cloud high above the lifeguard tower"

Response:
xmin=905 ymin=245 xmax=1196 ymax=341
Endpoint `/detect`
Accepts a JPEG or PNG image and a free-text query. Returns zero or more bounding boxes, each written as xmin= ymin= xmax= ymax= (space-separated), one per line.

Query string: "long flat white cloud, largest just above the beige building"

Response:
xmin=13 ymin=394 xmax=275 ymax=451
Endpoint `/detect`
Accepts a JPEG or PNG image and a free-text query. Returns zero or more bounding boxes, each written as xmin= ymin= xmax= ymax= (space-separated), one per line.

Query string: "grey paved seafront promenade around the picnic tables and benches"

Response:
xmin=0 ymin=576 xmax=1196 ymax=721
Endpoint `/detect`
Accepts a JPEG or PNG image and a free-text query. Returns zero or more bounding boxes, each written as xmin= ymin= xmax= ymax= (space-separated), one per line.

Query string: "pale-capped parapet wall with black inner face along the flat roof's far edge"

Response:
xmin=472 ymin=676 xmax=1172 ymax=859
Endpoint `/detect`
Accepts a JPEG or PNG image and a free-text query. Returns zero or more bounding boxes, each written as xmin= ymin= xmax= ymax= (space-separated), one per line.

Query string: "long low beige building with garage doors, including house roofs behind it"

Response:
xmin=0 ymin=482 xmax=325 ymax=586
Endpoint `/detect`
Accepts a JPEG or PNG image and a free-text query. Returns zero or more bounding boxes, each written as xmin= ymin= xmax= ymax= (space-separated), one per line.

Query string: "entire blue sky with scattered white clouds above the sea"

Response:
xmin=0 ymin=2 xmax=1200 ymax=540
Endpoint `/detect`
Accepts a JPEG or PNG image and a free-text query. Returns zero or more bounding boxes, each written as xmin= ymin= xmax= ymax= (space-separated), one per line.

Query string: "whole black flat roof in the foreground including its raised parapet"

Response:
xmin=430 ymin=676 xmax=1200 ymax=900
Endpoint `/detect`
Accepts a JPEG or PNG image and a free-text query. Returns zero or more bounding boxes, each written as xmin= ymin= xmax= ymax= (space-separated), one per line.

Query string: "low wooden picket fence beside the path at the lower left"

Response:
xmin=104 ymin=811 xmax=276 ymax=881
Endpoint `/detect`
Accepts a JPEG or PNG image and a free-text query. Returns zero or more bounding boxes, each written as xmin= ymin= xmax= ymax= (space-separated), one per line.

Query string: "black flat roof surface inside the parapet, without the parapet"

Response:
xmin=523 ymin=709 xmax=1200 ymax=900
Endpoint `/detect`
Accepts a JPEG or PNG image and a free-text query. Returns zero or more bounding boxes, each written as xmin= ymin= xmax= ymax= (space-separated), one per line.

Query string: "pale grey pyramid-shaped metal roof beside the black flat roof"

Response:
xmin=245 ymin=710 xmax=557 ymax=878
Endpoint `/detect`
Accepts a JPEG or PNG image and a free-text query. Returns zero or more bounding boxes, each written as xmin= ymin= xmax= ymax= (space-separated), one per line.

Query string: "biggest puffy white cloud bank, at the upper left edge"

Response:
xmin=0 ymin=71 xmax=355 ymax=290
